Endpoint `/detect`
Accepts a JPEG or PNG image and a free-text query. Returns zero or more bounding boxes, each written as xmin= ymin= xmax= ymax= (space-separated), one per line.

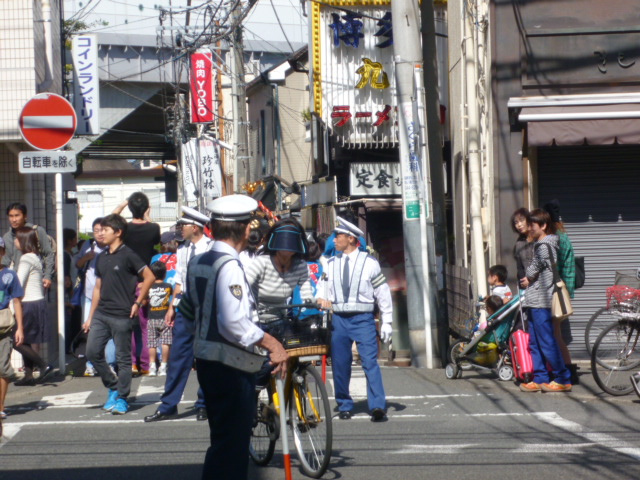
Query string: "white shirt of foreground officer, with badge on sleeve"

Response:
xmin=211 ymin=242 xmax=264 ymax=348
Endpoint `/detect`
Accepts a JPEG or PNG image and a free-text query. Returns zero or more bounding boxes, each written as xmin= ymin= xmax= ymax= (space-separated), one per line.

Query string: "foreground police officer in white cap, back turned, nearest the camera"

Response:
xmin=180 ymin=195 xmax=289 ymax=480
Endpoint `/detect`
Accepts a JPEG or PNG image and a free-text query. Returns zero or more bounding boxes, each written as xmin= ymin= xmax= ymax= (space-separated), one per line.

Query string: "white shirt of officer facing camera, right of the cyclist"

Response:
xmin=316 ymin=249 xmax=393 ymax=323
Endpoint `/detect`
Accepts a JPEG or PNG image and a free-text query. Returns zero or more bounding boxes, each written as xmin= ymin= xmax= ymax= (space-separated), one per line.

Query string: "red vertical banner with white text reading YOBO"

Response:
xmin=189 ymin=53 xmax=214 ymax=123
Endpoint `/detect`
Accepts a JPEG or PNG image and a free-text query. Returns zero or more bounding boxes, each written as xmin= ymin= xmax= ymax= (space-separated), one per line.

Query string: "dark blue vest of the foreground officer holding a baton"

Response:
xmin=186 ymin=251 xmax=265 ymax=373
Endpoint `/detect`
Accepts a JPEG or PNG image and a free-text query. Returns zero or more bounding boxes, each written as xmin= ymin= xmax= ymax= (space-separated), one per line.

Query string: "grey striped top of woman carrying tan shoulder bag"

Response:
xmin=524 ymin=235 xmax=558 ymax=308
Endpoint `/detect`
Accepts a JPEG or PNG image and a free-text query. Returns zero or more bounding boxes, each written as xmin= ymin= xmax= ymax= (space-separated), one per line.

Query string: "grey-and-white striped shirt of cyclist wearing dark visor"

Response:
xmin=246 ymin=254 xmax=313 ymax=321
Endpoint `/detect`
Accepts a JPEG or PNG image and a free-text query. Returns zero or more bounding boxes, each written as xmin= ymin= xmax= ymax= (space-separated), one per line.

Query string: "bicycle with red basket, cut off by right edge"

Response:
xmin=591 ymin=272 xmax=640 ymax=395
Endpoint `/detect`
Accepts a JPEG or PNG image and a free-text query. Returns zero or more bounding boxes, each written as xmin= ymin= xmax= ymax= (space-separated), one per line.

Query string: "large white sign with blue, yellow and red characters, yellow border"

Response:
xmin=311 ymin=0 xmax=397 ymax=148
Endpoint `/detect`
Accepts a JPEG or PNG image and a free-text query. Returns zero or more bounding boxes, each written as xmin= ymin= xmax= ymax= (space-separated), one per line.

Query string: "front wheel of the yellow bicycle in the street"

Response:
xmin=289 ymin=365 xmax=333 ymax=478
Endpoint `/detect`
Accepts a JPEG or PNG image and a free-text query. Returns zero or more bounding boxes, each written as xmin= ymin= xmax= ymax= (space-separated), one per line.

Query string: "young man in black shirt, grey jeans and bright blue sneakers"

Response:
xmin=83 ymin=214 xmax=155 ymax=415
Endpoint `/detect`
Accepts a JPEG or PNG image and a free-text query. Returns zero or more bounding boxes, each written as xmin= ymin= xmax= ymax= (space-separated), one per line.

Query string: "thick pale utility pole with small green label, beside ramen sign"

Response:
xmin=391 ymin=0 xmax=435 ymax=368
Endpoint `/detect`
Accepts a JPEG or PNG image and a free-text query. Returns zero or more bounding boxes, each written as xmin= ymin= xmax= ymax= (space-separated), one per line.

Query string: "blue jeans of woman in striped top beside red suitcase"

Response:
xmin=529 ymin=308 xmax=571 ymax=385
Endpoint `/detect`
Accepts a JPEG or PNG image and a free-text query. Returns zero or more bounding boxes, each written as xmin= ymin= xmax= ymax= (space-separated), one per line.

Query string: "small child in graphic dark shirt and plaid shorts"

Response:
xmin=147 ymin=262 xmax=173 ymax=376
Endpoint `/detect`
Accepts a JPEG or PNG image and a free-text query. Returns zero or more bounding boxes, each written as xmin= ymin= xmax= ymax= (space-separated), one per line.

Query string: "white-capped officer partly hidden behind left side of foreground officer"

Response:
xmin=144 ymin=207 xmax=214 ymax=422
